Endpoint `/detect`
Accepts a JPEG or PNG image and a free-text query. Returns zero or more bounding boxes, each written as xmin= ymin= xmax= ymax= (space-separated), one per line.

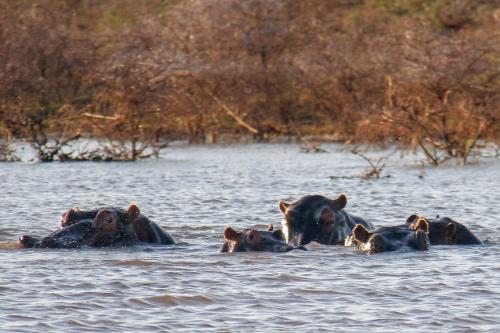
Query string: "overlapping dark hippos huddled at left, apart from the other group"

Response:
xmin=19 ymin=204 xmax=175 ymax=248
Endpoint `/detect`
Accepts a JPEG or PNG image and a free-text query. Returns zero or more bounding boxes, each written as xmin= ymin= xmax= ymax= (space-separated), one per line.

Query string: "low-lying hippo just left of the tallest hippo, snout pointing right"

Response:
xmin=220 ymin=227 xmax=306 ymax=253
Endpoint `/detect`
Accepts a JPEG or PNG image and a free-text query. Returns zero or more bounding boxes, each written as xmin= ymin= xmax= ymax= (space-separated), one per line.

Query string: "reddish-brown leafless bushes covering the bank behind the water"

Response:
xmin=0 ymin=0 xmax=500 ymax=164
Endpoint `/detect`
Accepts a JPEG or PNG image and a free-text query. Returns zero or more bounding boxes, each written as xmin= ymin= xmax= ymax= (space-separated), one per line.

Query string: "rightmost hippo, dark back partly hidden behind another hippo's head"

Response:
xmin=406 ymin=215 xmax=482 ymax=245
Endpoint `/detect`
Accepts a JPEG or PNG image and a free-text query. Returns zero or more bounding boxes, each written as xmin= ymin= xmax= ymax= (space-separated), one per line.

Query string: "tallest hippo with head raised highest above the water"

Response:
xmin=279 ymin=194 xmax=373 ymax=245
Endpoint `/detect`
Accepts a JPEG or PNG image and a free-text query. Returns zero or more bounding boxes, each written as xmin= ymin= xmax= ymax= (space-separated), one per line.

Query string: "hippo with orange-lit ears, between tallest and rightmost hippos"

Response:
xmin=352 ymin=219 xmax=430 ymax=254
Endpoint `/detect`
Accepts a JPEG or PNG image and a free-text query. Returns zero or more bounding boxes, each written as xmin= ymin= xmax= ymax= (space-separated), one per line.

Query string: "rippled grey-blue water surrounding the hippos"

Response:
xmin=0 ymin=145 xmax=500 ymax=332
